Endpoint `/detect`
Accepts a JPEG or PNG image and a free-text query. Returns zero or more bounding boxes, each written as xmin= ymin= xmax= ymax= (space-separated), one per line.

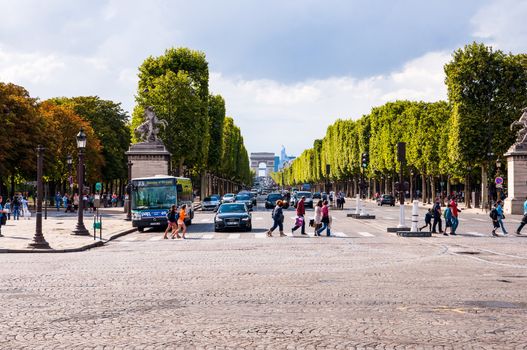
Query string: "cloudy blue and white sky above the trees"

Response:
xmin=0 ymin=0 xmax=527 ymax=156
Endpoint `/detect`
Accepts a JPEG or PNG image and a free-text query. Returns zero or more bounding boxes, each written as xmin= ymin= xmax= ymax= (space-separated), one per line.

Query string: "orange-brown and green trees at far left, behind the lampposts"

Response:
xmin=0 ymin=83 xmax=130 ymax=194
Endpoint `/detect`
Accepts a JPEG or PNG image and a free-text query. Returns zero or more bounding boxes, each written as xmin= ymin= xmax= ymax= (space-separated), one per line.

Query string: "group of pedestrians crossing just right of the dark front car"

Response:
xmin=267 ymin=196 xmax=331 ymax=237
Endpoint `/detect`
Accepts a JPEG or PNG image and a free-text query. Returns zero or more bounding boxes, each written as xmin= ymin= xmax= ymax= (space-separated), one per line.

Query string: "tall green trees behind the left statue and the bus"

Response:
xmin=131 ymin=48 xmax=252 ymax=189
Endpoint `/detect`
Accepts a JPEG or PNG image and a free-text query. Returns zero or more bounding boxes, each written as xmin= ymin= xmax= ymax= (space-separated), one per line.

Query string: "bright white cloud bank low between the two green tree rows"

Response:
xmin=210 ymin=52 xmax=450 ymax=155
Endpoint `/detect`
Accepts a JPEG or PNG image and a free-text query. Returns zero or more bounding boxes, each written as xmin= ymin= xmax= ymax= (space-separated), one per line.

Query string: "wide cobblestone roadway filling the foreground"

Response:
xmin=0 ymin=202 xmax=527 ymax=349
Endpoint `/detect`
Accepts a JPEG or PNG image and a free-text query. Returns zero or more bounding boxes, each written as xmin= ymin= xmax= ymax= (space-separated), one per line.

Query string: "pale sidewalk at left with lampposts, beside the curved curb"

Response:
xmin=0 ymin=207 xmax=135 ymax=253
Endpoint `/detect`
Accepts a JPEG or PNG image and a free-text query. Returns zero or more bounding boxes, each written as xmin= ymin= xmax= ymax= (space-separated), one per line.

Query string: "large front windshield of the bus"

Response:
xmin=132 ymin=179 xmax=177 ymax=210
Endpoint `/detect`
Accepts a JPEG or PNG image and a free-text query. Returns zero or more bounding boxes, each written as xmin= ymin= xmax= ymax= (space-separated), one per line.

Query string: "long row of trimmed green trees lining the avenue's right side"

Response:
xmin=274 ymin=43 xmax=527 ymax=204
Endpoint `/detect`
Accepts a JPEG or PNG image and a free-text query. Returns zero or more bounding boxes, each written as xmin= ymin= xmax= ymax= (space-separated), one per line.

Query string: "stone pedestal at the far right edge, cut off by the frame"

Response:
xmin=504 ymin=143 xmax=527 ymax=215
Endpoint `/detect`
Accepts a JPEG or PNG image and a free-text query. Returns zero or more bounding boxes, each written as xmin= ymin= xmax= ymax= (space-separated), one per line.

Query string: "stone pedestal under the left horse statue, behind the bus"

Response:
xmin=126 ymin=141 xmax=170 ymax=179
